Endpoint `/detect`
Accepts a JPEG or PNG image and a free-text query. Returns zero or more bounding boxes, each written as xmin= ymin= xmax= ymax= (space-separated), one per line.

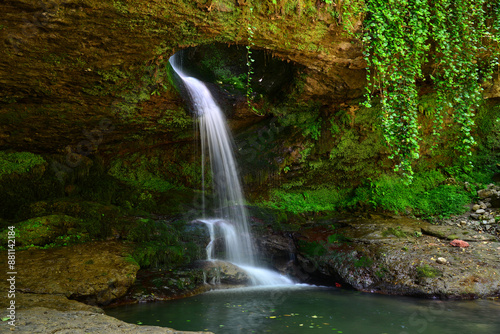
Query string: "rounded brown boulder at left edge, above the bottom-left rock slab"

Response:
xmin=0 ymin=242 xmax=139 ymax=304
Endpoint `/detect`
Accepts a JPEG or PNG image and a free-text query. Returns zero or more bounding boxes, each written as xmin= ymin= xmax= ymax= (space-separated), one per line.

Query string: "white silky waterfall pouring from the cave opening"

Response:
xmin=169 ymin=55 xmax=292 ymax=285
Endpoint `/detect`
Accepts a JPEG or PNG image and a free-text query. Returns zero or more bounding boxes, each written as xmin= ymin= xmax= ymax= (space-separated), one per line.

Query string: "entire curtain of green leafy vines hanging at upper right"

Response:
xmin=363 ymin=0 xmax=499 ymax=182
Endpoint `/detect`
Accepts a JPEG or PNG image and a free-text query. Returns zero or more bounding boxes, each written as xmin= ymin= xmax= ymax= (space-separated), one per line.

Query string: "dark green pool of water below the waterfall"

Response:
xmin=106 ymin=285 xmax=500 ymax=334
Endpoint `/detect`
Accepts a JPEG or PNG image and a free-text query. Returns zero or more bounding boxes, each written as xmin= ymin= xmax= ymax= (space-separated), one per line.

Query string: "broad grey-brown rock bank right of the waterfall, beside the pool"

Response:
xmin=288 ymin=218 xmax=500 ymax=299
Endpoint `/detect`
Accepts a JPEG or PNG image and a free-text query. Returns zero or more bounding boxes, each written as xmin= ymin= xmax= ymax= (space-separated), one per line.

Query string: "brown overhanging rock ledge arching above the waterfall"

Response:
xmin=0 ymin=0 xmax=365 ymax=154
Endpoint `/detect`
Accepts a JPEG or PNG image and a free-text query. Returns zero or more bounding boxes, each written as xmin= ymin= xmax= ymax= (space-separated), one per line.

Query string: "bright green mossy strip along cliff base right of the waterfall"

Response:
xmin=261 ymin=167 xmax=476 ymax=217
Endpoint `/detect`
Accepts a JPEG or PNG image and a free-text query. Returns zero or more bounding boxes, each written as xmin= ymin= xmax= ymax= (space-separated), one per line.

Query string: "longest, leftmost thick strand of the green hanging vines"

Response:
xmin=363 ymin=0 xmax=430 ymax=181
